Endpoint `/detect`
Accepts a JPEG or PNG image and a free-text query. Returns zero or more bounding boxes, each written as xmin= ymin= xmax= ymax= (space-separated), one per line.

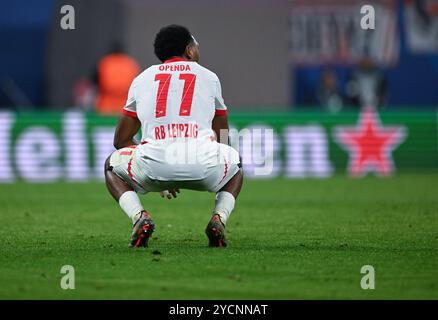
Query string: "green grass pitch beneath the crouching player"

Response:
xmin=0 ymin=174 xmax=438 ymax=299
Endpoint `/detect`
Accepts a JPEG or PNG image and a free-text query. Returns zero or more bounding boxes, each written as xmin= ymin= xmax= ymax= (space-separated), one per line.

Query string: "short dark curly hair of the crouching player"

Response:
xmin=154 ymin=24 xmax=193 ymax=62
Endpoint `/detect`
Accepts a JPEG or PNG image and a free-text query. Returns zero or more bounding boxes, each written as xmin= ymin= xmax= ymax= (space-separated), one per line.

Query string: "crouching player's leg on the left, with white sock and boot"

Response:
xmin=104 ymin=150 xmax=155 ymax=248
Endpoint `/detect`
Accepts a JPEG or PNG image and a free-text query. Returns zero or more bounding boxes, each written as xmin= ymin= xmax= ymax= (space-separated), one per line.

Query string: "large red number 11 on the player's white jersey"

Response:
xmin=155 ymin=73 xmax=196 ymax=118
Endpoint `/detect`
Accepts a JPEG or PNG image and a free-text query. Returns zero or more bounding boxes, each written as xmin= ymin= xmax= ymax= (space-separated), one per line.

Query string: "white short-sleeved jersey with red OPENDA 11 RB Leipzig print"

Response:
xmin=123 ymin=58 xmax=227 ymax=156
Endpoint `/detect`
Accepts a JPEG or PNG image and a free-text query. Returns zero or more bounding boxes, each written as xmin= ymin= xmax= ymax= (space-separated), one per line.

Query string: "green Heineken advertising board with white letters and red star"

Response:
xmin=0 ymin=109 xmax=438 ymax=183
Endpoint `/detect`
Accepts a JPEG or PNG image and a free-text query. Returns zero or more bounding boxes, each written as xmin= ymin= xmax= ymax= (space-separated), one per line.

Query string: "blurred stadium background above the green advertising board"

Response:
xmin=0 ymin=0 xmax=438 ymax=115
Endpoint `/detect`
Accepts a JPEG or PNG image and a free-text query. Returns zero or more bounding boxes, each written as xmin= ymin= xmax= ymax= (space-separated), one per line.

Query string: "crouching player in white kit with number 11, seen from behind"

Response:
xmin=105 ymin=25 xmax=243 ymax=248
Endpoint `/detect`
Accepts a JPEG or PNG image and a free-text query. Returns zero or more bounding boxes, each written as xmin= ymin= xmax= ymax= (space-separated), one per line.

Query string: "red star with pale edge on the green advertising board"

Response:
xmin=334 ymin=107 xmax=406 ymax=176
